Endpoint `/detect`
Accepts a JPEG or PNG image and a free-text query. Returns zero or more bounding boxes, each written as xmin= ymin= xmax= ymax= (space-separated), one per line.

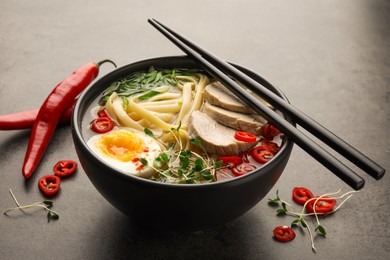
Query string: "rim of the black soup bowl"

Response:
xmin=71 ymin=56 xmax=295 ymax=189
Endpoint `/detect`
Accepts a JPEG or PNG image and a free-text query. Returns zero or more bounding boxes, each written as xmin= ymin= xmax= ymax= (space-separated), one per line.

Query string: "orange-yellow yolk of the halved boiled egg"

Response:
xmin=96 ymin=131 xmax=145 ymax=162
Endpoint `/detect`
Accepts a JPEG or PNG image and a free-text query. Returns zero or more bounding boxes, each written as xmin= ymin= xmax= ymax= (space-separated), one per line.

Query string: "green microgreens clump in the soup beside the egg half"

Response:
xmin=140 ymin=125 xmax=222 ymax=184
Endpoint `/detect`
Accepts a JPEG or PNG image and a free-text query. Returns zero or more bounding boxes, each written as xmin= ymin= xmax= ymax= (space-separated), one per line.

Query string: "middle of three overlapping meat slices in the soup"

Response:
xmin=202 ymin=102 xmax=267 ymax=135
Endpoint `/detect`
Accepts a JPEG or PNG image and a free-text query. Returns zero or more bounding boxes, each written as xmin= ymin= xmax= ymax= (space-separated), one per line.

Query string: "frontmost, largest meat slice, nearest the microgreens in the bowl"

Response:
xmin=190 ymin=111 xmax=257 ymax=156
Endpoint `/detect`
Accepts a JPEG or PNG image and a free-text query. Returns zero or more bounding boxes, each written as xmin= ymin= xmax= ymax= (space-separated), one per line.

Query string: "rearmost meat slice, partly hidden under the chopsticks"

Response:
xmin=204 ymin=81 xmax=273 ymax=114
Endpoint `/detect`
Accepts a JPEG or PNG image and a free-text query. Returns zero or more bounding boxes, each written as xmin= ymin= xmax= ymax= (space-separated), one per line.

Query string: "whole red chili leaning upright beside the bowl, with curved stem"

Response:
xmin=22 ymin=60 xmax=115 ymax=179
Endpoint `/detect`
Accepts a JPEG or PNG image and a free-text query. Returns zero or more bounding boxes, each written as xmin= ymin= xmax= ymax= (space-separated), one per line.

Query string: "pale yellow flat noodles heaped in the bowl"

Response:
xmin=104 ymin=71 xmax=209 ymax=149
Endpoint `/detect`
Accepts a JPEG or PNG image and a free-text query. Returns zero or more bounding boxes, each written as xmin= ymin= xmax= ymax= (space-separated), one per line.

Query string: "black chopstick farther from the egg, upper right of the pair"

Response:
xmin=148 ymin=19 xmax=385 ymax=180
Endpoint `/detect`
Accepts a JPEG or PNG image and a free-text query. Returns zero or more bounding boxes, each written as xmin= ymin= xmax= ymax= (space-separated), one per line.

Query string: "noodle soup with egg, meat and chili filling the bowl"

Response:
xmin=83 ymin=67 xmax=283 ymax=184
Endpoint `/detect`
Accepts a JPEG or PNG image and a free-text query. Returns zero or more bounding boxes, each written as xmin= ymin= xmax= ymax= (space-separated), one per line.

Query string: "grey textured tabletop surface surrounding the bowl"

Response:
xmin=0 ymin=0 xmax=390 ymax=259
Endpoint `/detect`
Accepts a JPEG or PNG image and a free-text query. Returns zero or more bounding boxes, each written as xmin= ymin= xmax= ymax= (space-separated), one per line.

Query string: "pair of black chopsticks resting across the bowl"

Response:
xmin=148 ymin=19 xmax=385 ymax=190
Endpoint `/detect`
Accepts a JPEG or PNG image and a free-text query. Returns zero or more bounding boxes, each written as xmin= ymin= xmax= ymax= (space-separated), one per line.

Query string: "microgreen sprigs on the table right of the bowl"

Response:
xmin=268 ymin=190 xmax=357 ymax=253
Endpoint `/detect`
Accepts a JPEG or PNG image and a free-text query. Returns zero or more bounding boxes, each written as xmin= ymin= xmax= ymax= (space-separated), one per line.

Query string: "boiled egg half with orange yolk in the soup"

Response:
xmin=87 ymin=128 xmax=161 ymax=178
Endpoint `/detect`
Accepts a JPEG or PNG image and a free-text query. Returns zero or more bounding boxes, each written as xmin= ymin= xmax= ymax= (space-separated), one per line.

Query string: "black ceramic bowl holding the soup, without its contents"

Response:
xmin=72 ymin=56 xmax=293 ymax=231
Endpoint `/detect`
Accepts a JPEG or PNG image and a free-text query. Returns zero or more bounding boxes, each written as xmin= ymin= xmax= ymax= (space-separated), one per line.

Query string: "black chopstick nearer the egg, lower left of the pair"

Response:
xmin=148 ymin=19 xmax=365 ymax=190
